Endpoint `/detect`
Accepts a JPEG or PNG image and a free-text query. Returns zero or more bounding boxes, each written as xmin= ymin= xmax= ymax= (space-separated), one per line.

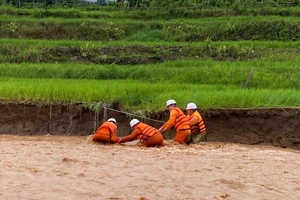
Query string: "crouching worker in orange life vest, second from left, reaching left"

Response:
xmin=120 ymin=119 xmax=164 ymax=147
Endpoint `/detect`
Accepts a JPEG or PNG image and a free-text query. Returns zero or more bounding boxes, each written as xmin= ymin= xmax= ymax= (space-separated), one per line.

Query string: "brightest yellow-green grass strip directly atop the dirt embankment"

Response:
xmin=0 ymin=78 xmax=300 ymax=111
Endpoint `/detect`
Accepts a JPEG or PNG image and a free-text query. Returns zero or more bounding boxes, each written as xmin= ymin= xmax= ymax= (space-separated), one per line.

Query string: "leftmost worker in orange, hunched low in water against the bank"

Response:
xmin=92 ymin=118 xmax=120 ymax=144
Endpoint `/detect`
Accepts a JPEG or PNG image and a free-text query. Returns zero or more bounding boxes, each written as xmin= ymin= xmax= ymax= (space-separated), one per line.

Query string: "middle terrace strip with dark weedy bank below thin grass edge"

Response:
xmin=0 ymin=39 xmax=300 ymax=65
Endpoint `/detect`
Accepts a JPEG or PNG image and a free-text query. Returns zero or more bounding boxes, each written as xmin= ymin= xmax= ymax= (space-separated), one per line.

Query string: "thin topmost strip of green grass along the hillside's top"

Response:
xmin=0 ymin=4 xmax=300 ymax=20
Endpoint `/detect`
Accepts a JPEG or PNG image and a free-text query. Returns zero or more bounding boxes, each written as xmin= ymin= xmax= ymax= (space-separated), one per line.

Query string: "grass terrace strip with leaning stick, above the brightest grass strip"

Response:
xmin=0 ymin=60 xmax=300 ymax=89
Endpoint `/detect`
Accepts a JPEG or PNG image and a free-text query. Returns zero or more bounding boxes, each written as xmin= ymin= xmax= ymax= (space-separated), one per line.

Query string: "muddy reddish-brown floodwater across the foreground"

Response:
xmin=0 ymin=135 xmax=300 ymax=200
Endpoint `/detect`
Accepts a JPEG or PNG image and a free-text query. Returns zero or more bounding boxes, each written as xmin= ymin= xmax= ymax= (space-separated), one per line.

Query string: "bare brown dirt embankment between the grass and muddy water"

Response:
xmin=0 ymin=102 xmax=300 ymax=149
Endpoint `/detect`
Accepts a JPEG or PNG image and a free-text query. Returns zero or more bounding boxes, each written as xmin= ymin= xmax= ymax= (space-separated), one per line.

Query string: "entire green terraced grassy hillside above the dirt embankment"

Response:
xmin=0 ymin=8 xmax=300 ymax=111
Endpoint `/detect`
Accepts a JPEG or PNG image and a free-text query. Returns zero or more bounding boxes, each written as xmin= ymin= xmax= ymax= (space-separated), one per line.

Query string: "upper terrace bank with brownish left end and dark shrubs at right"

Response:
xmin=0 ymin=16 xmax=300 ymax=42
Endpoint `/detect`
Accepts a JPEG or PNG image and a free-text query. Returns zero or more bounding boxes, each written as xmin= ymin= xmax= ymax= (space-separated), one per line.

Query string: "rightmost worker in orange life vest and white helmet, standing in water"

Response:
xmin=186 ymin=103 xmax=206 ymax=144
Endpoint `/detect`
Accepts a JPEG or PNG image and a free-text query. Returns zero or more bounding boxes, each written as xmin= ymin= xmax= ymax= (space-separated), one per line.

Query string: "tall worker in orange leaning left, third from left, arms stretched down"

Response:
xmin=159 ymin=99 xmax=191 ymax=144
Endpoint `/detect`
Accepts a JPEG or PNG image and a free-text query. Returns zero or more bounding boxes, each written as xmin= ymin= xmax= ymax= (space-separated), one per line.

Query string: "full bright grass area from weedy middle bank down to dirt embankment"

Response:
xmin=0 ymin=57 xmax=300 ymax=111
